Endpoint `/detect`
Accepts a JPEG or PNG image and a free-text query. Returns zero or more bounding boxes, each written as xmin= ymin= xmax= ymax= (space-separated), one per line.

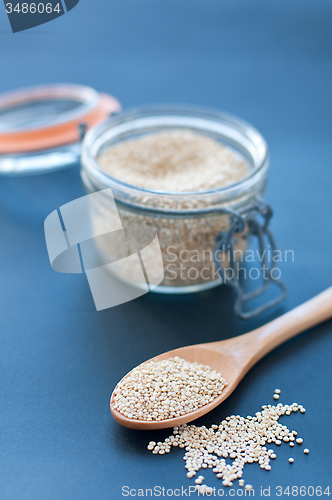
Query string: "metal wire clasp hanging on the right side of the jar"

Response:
xmin=214 ymin=197 xmax=287 ymax=319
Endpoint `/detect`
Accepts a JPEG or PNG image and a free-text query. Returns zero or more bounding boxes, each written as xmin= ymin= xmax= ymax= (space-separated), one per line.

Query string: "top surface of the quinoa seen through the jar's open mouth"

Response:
xmin=98 ymin=130 xmax=248 ymax=192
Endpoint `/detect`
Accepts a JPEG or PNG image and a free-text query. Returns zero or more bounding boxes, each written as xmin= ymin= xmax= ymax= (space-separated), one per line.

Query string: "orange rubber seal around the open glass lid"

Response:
xmin=0 ymin=87 xmax=121 ymax=154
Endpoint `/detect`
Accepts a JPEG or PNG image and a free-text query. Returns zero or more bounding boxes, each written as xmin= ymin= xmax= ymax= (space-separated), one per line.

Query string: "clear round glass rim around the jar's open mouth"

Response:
xmin=82 ymin=103 xmax=269 ymax=201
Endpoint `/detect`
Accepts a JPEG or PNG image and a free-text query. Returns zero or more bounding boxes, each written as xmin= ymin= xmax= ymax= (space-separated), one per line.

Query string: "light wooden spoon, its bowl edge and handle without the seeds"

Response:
xmin=110 ymin=287 xmax=332 ymax=430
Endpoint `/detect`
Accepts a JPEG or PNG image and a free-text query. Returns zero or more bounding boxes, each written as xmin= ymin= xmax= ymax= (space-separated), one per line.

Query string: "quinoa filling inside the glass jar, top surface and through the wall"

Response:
xmin=93 ymin=130 xmax=250 ymax=286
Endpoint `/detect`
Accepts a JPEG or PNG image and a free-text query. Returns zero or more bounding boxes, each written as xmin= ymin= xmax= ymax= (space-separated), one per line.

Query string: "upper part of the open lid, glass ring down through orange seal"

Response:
xmin=0 ymin=84 xmax=120 ymax=156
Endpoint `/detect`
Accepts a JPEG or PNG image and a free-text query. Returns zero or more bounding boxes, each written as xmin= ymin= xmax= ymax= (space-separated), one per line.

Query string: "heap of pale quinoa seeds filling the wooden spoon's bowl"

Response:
xmin=114 ymin=357 xmax=227 ymax=422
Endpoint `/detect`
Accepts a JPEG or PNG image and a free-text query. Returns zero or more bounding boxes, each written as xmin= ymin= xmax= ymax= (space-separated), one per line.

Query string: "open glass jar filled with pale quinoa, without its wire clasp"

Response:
xmin=82 ymin=105 xmax=286 ymax=316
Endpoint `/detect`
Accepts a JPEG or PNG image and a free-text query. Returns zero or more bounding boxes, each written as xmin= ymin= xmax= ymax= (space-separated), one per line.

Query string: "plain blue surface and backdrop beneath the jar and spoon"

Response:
xmin=0 ymin=0 xmax=332 ymax=500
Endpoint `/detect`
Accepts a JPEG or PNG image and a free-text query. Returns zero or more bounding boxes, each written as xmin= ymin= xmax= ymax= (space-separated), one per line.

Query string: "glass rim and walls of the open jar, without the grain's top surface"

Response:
xmin=81 ymin=105 xmax=269 ymax=293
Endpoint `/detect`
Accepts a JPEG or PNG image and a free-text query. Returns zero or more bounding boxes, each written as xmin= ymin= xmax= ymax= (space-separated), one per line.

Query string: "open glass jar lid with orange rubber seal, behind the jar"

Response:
xmin=0 ymin=84 xmax=121 ymax=175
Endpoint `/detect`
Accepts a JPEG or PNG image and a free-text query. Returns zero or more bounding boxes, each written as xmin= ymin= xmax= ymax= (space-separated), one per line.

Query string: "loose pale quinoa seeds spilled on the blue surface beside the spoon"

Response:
xmin=149 ymin=403 xmax=309 ymax=494
